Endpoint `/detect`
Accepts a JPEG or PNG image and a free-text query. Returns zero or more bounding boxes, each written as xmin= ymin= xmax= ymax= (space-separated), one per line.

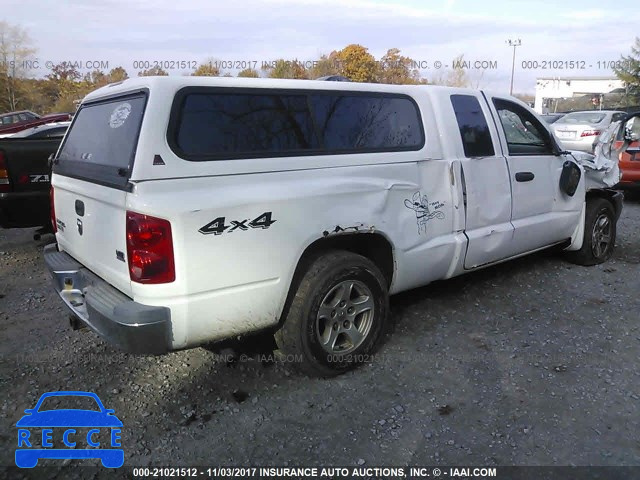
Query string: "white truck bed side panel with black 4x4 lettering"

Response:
xmin=128 ymin=162 xmax=444 ymax=348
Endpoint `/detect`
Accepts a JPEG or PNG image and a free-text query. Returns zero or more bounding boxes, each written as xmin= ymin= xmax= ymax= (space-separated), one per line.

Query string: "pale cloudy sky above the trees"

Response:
xmin=0 ymin=0 xmax=640 ymax=94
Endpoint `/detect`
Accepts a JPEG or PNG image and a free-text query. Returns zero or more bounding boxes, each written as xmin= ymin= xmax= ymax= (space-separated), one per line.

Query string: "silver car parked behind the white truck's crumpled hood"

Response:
xmin=551 ymin=110 xmax=627 ymax=153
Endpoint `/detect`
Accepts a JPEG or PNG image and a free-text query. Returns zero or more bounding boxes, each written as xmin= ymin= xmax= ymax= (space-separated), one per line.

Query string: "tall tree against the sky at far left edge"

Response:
xmin=0 ymin=21 xmax=36 ymax=110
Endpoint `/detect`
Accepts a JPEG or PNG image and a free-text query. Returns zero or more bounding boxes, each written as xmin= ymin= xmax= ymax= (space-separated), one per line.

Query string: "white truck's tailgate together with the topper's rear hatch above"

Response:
xmin=52 ymin=92 xmax=146 ymax=296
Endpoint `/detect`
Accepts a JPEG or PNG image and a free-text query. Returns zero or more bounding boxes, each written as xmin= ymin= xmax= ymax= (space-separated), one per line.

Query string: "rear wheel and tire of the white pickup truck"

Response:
xmin=275 ymin=250 xmax=390 ymax=377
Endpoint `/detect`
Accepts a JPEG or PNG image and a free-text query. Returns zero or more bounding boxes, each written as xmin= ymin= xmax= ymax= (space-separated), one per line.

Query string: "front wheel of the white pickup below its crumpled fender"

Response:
xmin=567 ymin=198 xmax=616 ymax=266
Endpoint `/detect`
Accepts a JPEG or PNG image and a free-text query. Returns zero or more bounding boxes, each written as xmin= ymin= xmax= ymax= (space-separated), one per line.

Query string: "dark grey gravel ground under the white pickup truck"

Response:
xmin=0 ymin=195 xmax=640 ymax=473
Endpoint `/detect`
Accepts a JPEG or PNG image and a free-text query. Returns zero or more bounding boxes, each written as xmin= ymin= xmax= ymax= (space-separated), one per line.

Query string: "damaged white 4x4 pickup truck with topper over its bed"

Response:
xmin=45 ymin=77 xmax=622 ymax=375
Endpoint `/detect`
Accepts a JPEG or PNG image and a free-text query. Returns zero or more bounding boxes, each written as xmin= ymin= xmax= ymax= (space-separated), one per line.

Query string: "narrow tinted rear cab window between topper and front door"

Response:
xmin=451 ymin=95 xmax=495 ymax=157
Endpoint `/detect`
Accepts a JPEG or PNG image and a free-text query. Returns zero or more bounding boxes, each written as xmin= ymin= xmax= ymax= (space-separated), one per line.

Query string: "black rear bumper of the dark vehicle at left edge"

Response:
xmin=0 ymin=190 xmax=49 ymax=228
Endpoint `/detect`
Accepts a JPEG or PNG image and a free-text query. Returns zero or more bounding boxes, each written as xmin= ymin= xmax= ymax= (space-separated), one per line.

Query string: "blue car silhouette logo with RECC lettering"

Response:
xmin=16 ymin=391 xmax=124 ymax=468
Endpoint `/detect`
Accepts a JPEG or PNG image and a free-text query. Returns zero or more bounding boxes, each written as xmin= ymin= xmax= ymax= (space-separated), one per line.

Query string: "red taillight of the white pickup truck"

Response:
xmin=127 ymin=211 xmax=176 ymax=284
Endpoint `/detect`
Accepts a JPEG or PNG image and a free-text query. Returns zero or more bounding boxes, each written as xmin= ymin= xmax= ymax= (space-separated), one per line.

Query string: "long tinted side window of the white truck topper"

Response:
xmin=168 ymin=89 xmax=424 ymax=160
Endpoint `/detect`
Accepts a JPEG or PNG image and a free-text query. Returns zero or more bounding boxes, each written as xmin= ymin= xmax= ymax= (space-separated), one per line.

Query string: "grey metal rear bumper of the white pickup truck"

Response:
xmin=44 ymin=244 xmax=171 ymax=354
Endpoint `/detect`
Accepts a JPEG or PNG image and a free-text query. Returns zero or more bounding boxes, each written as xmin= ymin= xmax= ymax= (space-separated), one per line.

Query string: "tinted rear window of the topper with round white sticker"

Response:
xmin=58 ymin=94 xmax=145 ymax=169
